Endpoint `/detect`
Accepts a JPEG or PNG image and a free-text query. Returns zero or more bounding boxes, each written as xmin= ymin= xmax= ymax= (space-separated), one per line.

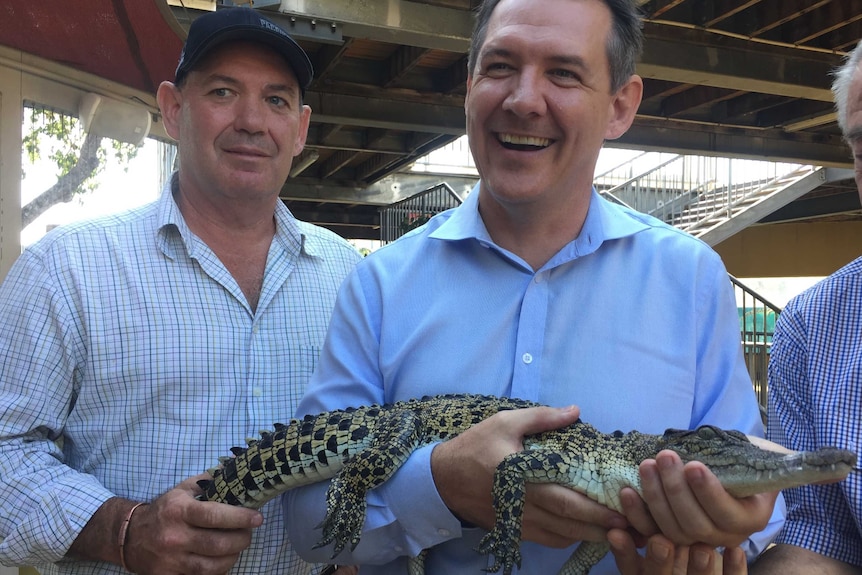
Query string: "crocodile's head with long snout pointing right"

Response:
xmin=657 ymin=425 xmax=856 ymax=497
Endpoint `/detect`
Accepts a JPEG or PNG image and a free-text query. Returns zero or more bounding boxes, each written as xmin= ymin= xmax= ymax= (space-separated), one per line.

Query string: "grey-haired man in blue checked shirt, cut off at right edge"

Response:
xmin=752 ymin=40 xmax=862 ymax=575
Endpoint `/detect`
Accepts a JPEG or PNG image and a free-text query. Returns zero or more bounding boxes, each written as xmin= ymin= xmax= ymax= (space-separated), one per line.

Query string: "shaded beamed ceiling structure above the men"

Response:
xmin=0 ymin=0 xmax=862 ymax=237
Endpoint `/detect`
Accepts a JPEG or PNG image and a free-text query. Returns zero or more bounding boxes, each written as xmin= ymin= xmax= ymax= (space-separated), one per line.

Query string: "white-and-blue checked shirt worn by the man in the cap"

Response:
xmin=0 ymin=177 xmax=359 ymax=575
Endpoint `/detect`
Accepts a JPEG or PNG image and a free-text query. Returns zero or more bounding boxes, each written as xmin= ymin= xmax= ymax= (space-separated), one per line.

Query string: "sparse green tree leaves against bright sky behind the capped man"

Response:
xmin=22 ymin=108 xmax=138 ymax=193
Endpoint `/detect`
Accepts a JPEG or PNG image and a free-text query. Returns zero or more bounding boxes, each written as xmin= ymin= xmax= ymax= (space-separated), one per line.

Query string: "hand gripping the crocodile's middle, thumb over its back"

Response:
xmin=431 ymin=407 xmax=628 ymax=548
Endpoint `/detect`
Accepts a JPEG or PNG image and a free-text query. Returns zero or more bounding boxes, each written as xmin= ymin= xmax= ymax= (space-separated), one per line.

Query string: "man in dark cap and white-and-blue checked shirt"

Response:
xmin=0 ymin=8 xmax=359 ymax=575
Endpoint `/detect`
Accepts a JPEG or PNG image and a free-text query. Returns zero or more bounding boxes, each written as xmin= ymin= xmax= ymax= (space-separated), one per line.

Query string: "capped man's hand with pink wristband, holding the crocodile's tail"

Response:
xmin=125 ymin=474 xmax=263 ymax=575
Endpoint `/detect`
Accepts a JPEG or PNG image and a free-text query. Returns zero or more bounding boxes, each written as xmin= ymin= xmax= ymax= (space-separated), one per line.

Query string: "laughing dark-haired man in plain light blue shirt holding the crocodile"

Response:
xmin=285 ymin=0 xmax=781 ymax=575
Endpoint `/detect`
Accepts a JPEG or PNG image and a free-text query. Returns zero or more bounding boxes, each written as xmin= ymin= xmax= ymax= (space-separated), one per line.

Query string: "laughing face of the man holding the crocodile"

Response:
xmin=465 ymin=0 xmax=642 ymax=217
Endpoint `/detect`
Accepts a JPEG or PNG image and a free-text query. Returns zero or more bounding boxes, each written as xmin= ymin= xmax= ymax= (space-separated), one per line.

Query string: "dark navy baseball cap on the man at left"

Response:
xmin=174 ymin=7 xmax=314 ymax=95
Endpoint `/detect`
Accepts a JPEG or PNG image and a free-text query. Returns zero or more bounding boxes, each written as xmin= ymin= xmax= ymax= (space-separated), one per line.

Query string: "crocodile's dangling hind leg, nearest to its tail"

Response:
xmin=315 ymin=410 xmax=422 ymax=557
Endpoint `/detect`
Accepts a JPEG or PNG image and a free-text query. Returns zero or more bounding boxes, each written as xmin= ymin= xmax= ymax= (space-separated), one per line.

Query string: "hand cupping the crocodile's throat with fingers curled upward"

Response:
xmin=620 ymin=451 xmax=778 ymax=548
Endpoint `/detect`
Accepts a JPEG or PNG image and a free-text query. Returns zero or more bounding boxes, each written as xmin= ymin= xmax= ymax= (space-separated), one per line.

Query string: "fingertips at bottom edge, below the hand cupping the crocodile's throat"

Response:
xmin=608 ymin=529 xmax=748 ymax=575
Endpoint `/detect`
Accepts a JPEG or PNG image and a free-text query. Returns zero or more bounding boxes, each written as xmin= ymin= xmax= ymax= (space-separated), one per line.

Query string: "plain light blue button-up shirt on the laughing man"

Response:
xmin=285 ymin=190 xmax=781 ymax=575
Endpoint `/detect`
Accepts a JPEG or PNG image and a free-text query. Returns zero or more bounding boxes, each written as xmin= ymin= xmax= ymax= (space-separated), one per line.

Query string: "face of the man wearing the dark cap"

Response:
xmin=158 ymin=42 xmax=311 ymax=212
